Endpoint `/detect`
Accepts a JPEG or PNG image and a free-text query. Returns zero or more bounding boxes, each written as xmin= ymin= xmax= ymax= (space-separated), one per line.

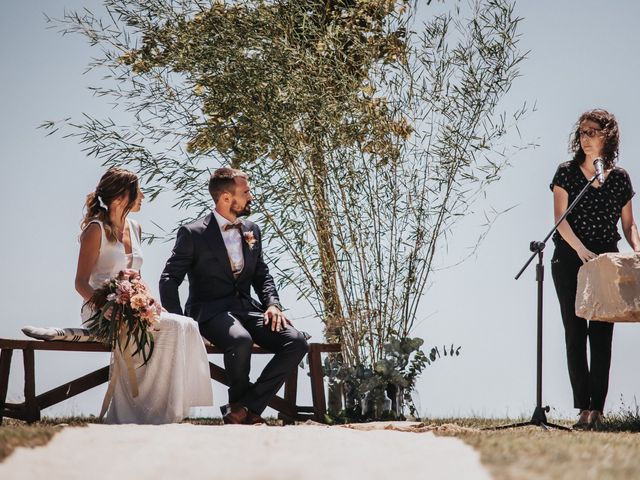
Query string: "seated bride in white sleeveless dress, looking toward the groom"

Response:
xmin=76 ymin=168 xmax=213 ymax=424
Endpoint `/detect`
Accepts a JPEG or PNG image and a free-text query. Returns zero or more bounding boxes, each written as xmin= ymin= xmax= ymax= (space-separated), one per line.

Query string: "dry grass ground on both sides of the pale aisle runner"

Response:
xmin=5 ymin=410 xmax=640 ymax=480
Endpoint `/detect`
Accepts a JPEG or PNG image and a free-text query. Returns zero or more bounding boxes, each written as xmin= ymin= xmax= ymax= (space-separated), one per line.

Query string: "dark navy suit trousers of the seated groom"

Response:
xmin=199 ymin=311 xmax=309 ymax=414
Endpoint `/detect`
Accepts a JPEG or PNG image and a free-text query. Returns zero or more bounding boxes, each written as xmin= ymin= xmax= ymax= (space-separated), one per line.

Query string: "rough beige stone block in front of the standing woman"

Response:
xmin=576 ymin=253 xmax=640 ymax=322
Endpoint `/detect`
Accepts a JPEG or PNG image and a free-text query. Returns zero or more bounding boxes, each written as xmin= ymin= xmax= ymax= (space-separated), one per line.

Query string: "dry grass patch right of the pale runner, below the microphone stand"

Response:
xmin=430 ymin=411 xmax=640 ymax=480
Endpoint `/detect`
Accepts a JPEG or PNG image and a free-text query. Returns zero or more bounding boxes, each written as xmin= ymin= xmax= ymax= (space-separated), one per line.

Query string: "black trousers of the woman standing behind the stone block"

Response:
xmin=551 ymin=244 xmax=618 ymax=412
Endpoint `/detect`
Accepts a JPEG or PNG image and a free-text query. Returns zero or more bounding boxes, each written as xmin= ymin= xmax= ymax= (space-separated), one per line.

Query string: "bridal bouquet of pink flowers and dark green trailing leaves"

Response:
xmin=86 ymin=271 xmax=162 ymax=363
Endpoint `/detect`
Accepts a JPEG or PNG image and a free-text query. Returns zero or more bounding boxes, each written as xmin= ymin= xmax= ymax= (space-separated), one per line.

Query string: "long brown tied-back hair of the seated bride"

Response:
xmin=80 ymin=167 xmax=138 ymax=242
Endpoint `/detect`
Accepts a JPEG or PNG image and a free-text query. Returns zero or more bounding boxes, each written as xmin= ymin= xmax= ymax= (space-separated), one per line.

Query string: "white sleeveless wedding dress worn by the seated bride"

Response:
xmin=81 ymin=220 xmax=213 ymax=424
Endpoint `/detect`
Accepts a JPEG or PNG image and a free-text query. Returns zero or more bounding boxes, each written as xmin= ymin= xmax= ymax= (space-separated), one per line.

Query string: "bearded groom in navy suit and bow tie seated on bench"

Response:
xmin=160 ymin=168 xmax=308 ymax=424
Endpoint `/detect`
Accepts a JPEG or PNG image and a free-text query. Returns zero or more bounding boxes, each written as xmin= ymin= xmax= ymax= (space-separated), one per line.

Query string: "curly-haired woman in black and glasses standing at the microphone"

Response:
xmin=551 ymin=109 xmax=640 ymax=428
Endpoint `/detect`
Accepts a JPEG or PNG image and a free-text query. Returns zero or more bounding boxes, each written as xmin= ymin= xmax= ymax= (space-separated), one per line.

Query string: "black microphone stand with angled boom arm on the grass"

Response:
xmin=493 ymin=174 xmax=598 ymax=430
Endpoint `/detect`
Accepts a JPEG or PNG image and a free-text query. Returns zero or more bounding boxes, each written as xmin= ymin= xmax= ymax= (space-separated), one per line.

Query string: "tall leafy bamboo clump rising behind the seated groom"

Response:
xmin=45 ymin=0 xmax=527 ymax=412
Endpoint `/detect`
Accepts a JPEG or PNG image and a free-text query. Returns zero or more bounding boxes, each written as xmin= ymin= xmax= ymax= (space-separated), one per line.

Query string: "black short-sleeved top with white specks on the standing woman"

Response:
xmin=550 ymin=160 xmax=635 ymax=248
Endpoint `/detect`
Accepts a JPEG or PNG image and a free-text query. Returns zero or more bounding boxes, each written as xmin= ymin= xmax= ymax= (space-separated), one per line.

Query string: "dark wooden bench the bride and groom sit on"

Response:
xmin=0 ymin=338 xmax=340 ymax=425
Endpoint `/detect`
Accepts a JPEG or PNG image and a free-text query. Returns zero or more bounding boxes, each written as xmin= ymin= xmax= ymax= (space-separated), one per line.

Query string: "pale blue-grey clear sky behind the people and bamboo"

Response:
xmin=0 ymin=0 xmax=640 ymax=416
